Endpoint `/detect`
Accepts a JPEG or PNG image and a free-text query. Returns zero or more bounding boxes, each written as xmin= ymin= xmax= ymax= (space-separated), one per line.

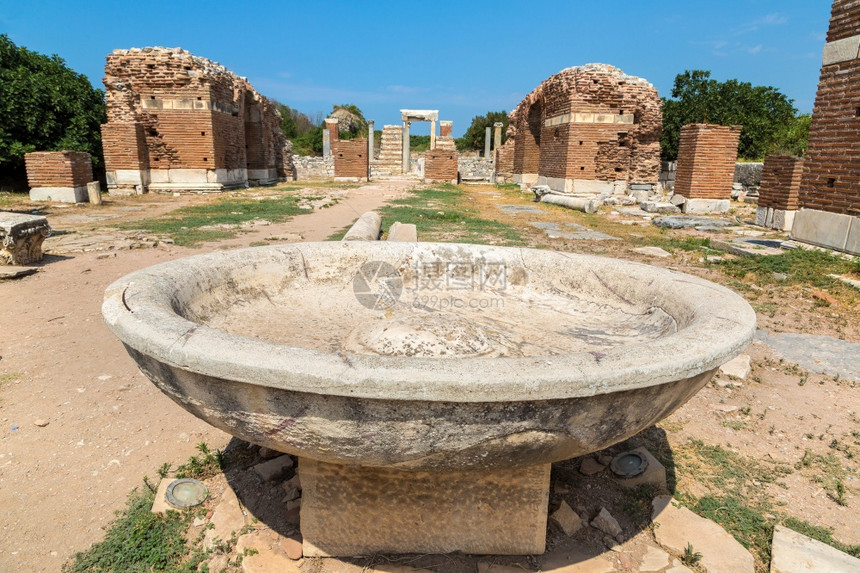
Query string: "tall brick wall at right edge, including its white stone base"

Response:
xmin=791 ymin=0 xmax=860 ymax=254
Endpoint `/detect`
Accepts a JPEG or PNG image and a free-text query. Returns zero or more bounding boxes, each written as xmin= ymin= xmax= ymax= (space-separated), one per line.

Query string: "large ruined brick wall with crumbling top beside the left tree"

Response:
xmin=102 ymin=48 xmax=285 ymax=193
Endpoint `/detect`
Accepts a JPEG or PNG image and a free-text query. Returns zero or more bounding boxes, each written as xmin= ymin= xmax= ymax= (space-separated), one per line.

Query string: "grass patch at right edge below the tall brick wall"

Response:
xmin=715 ymin=249 xmax=860 ymax=288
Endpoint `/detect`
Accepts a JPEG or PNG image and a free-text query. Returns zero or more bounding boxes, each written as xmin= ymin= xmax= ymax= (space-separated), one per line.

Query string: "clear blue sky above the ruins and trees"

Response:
xmin=0 ymin=0 xmax=830 ymax=135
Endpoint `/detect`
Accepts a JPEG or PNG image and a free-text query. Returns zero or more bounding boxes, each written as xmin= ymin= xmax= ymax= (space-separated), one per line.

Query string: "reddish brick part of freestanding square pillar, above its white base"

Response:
xmin=675 ymin=123 xmax=741 ymax=199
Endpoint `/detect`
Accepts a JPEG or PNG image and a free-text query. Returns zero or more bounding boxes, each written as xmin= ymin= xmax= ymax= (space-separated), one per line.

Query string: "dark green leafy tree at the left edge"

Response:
xmin=0 ymin=34 xmax=106 ymax=178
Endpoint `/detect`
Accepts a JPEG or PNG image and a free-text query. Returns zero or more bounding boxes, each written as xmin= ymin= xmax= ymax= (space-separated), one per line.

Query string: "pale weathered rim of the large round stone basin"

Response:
xmin=102 ymin=242 xmax=755 ymax=402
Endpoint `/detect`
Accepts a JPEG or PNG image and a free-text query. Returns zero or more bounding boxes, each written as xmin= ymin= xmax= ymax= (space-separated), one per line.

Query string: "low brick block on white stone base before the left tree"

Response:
xmin=24 ymin=151 xmax=93 ymax=203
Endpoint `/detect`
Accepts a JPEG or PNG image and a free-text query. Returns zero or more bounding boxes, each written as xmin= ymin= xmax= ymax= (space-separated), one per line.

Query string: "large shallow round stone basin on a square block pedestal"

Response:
xmin=103 ymin=242 xmax=755 ymax=554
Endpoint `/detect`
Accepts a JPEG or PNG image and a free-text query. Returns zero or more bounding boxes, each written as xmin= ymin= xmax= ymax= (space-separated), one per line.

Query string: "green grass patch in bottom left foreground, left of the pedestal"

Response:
xmin=63 ymin=480 xmax=205 ymax=573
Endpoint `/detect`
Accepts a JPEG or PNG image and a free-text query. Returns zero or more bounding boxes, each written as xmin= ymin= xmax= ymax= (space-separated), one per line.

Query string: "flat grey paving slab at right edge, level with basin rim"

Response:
xmin=756 ymin=330 xmax=860 ymax=380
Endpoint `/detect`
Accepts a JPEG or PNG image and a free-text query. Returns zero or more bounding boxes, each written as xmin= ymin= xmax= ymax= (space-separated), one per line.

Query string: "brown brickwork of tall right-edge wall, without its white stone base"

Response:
xmin=800 ymin=0 xmax=860 ymax=216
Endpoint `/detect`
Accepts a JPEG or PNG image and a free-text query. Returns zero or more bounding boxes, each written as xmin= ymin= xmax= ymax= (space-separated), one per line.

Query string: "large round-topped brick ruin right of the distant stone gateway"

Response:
xmin=497 ymin=64 xmax=663 ymax=193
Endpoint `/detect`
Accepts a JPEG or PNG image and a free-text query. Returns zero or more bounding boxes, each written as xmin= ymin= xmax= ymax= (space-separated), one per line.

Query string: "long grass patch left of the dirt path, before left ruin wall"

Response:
xmin=123 ymin=195 xmax=310 ymax=247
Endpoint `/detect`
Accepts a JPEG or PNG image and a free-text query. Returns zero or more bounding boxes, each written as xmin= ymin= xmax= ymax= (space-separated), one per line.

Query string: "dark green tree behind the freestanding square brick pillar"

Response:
xmin=660 ymin=70 xmax=798 ymax=160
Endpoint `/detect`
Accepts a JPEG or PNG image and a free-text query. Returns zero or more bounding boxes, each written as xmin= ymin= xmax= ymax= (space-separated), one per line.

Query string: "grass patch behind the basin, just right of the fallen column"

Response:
xmin=374 ymin=184 xmax=527 ymax=246
